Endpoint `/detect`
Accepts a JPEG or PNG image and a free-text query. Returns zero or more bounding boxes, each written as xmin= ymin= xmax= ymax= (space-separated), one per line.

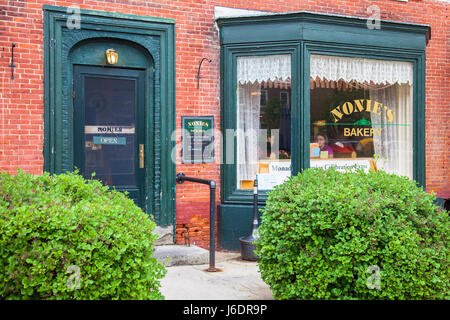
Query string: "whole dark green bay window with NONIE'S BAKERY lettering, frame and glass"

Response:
xmin=217 ymin=12 xmax=430 ymax=249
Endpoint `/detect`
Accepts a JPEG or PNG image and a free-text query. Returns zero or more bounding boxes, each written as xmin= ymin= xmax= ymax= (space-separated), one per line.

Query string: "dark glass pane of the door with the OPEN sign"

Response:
xmin=84 ymin=76 xmax=136 ymax=186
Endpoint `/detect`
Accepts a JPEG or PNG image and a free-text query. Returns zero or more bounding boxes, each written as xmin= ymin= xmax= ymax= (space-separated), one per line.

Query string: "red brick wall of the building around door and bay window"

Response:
xmin=0 ymin=0 xmax=450 ymax=247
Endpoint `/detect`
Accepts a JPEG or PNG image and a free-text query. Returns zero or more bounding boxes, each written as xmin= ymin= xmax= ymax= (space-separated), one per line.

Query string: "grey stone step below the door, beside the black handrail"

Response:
xmin=153 ymin=245 xmax=209 ymax=267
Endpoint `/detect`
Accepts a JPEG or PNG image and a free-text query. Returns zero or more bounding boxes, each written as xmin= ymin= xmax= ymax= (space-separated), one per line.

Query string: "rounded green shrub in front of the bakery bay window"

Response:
xmin=256 ymin=169 xmax=449 ymax=299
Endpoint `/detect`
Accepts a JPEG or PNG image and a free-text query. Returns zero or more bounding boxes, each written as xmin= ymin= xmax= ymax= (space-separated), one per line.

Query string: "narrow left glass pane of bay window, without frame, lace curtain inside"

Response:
xmin=236 ymin=55 xmax=291 ymax=189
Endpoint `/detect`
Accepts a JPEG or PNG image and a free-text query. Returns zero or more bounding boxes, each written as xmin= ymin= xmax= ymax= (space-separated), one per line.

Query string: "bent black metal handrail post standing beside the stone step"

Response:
xmin=176 ymin=172 xmax=217 ymax=272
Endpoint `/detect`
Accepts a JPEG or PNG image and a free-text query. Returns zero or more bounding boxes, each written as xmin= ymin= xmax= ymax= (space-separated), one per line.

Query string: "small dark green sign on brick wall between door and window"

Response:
xmin=181 ymin=117 xmax=214 ymax=163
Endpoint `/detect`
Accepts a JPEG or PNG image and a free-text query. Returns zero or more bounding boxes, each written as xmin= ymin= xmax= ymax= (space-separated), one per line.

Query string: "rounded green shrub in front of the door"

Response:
xmin=0 ymin=170 xmax=166 ymax=299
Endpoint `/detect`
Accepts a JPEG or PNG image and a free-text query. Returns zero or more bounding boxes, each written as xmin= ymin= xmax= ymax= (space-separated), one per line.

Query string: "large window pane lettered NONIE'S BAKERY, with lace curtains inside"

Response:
xmin=310 ymin=55 xmax=413 ymax=177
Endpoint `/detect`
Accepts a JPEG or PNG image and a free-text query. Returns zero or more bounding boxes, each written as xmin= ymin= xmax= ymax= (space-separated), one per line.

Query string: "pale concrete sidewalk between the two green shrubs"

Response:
xmin=161 ymin=252 xmax=273 ymax=300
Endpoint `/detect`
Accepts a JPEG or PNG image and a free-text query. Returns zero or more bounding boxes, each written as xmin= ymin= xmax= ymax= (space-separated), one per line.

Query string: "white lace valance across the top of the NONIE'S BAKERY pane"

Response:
xmin=310 ymin=55 xmax=413 ymax=85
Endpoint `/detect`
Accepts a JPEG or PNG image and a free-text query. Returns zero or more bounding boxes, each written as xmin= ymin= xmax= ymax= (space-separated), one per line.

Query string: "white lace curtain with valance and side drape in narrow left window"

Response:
xmin=237 ymin=55 xmax=291 ymax=188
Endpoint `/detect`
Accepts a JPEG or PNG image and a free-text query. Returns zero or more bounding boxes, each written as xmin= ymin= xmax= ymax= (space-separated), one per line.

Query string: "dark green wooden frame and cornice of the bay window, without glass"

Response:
xmin=217 ymin=12 xmax=430 ymax=204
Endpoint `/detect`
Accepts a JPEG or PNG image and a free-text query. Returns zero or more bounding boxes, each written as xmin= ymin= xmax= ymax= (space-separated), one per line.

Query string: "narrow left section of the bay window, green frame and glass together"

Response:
xmin=222 ymin=44 xmax=300 ymax=203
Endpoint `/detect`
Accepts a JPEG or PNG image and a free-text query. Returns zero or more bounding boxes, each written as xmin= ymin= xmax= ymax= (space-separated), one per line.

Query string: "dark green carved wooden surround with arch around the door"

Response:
xmin=43 ymin=5 xmax=175 ymax=228
